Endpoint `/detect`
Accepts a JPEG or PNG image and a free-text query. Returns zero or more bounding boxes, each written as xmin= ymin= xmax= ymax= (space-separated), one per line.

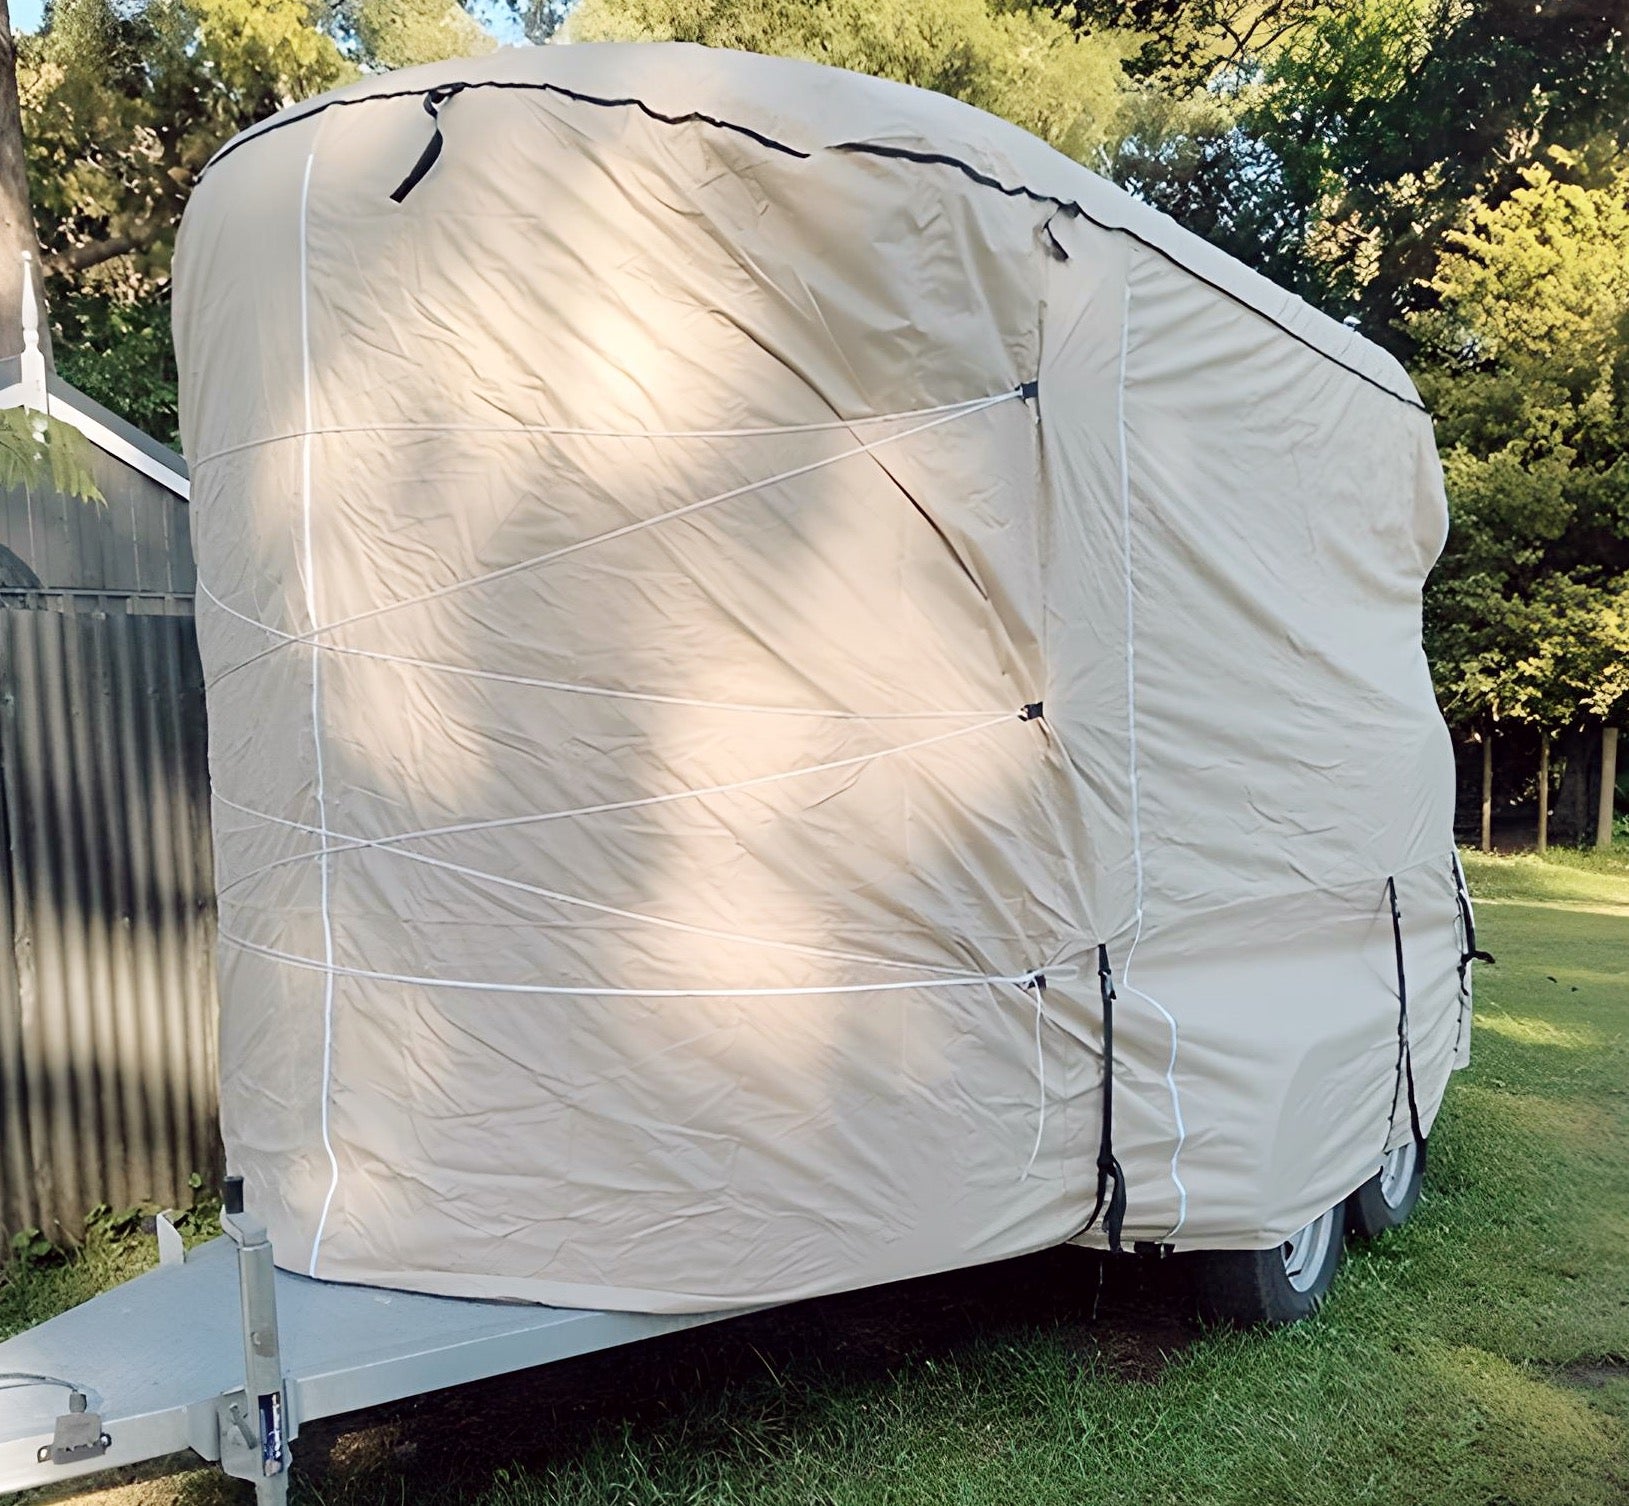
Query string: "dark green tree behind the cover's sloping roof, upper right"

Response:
xmin=1094 ymin=0 xmax=1629 ymax=343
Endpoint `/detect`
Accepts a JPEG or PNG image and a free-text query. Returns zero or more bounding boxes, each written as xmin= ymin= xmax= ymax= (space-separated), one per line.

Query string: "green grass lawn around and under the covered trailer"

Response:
xmin=0 ymin=854 xmax=1629 ymax=1506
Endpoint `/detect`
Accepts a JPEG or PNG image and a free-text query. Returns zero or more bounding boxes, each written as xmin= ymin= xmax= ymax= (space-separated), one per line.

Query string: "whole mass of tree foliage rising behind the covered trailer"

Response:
xmin=9 ymin=0 xmax=1629 ymax=766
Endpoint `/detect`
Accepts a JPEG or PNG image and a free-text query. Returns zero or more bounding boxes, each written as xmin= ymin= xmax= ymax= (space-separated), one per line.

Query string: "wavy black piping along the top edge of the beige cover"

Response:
xmin=204 ymin=78 xmax=1427 ymax=412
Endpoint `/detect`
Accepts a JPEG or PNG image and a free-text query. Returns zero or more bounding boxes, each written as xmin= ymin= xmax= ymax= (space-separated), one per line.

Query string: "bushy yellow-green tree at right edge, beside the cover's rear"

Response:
xmin=1409 ymin=142 xmax=1629 ymax=828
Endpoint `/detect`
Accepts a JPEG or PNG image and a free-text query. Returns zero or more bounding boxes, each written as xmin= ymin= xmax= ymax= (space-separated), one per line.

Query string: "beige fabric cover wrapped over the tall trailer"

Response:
xmin=176 ymin=46 xmax=1469 ymax=1310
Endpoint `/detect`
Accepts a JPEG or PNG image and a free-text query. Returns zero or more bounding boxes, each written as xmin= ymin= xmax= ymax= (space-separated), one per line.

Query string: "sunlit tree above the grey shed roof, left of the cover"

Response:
xmin=14 ymin=0 xmax=501 ymax=440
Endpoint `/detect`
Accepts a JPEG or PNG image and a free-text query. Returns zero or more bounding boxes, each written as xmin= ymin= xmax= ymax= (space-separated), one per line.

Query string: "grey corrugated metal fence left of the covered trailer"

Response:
xmin=0 ymin=606 xmax=220 ymax=1234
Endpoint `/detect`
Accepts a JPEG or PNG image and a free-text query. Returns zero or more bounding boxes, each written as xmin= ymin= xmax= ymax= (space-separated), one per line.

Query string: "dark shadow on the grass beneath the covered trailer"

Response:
xmin=276 ymin=1248 xmax=1199 ymax=1499
